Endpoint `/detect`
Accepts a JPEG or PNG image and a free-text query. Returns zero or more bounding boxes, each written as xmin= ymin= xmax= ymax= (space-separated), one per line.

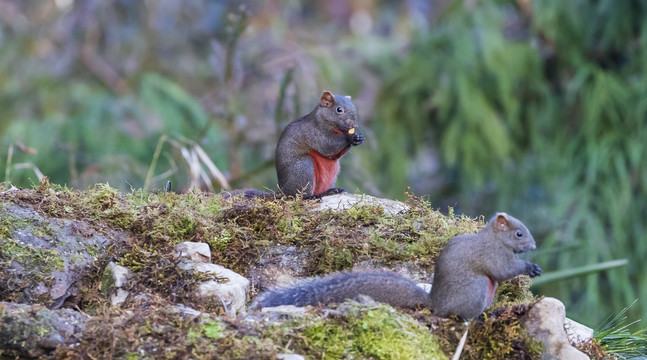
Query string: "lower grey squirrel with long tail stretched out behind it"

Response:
xmin=252 ymin=213 xmax=541 ymax=319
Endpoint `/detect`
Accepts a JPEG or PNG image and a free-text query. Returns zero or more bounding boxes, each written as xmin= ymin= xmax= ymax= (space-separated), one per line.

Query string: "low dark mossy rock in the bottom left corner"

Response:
xmin=0 ymin=302 xmax=85 ymax=358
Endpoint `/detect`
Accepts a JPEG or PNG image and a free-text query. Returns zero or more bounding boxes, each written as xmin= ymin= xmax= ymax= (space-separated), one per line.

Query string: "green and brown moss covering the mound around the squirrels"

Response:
xmin=0 ymin=181 xmax=612 ymax=359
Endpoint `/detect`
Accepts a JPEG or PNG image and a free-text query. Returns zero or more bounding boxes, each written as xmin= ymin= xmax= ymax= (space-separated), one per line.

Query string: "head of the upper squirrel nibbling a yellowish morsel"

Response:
xmin=317 ymin=91 xmax=358 ymax=134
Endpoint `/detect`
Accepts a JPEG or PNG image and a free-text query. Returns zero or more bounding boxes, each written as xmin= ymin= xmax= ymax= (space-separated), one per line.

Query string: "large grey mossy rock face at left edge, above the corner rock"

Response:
xmin=0 ymin=203 xmax=128 ymax=309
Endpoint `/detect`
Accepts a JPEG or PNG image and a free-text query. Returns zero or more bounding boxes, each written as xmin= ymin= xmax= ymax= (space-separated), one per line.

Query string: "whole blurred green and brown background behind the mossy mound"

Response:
xmin=0 ymin=0 xmax=647 ymax=327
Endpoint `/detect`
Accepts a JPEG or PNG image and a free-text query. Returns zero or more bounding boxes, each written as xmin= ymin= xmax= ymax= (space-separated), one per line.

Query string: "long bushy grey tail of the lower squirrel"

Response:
xmin=252 ymin=272 xmax=430 ymax=309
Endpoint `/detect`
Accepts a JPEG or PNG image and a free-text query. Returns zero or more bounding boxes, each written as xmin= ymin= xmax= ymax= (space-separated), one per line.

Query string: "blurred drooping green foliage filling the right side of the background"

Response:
xmin=369 ymin=0 xmax=647 ymax=323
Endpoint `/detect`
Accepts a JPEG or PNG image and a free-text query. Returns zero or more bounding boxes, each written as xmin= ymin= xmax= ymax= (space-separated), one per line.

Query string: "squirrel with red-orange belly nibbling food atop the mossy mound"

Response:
xmin=276 ymin=91 xmax=364 ymax=196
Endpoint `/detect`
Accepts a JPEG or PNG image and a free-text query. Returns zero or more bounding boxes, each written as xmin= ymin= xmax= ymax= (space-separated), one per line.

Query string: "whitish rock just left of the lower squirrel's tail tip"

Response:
xmin=179 ymin=261 xmax=250 ymax=317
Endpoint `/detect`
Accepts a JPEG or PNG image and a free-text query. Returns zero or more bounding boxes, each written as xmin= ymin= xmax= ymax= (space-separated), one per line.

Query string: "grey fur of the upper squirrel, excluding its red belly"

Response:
xmin=275 ymin=92 xmax=364 ymax=195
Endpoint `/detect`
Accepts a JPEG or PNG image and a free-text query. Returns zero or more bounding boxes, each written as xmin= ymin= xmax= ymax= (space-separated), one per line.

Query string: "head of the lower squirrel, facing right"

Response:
xmin=488 ymin=213 xmax=536 ymax=254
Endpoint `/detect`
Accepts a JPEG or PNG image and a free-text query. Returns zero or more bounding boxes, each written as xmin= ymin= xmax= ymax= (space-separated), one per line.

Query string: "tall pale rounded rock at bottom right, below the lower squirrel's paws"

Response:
xmin=524 ymin=298 xmax=589 ymax=360
